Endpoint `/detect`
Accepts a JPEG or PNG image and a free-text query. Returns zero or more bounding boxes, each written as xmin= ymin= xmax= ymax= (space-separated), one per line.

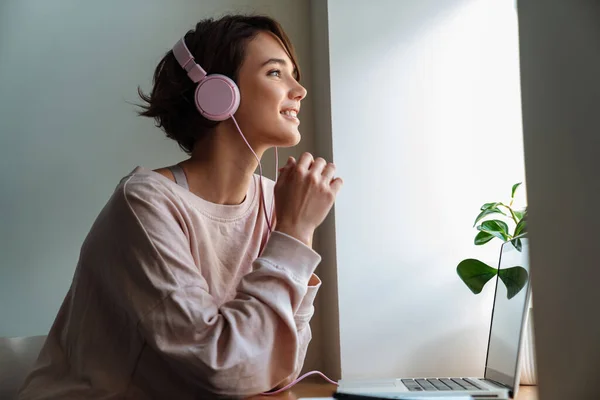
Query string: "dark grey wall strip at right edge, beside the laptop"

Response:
xmin=519 ymin=0 xmax=600 ymax=400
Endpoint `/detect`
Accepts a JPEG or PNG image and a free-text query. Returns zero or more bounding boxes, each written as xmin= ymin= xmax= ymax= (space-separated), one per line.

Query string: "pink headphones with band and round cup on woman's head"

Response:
xmin=173 ymin=38 xmax=240 ymax=121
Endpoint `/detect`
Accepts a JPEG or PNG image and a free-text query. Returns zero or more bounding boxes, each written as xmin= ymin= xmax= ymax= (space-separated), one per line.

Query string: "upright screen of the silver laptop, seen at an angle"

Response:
xmin=485 ymin=238 xmax=530 ymax=389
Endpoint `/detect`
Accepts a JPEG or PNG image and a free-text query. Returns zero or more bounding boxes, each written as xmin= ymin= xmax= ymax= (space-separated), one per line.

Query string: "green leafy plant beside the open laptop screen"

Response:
xmin=456 ymin=182 xmax=529 ymax=299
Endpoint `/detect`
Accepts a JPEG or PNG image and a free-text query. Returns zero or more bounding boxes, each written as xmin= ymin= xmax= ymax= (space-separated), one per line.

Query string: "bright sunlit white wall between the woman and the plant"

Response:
xmin=328 ymin=0 xmax=524 ymax=378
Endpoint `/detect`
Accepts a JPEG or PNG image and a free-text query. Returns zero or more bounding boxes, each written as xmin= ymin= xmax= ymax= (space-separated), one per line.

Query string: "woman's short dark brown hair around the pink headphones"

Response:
xmin=138 ymin=15 xmax=300 ymax=154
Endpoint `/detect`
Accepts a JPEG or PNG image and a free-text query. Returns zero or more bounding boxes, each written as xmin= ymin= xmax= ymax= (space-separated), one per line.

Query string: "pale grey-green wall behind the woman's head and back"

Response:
xmin=0 ymin=0 xmax=314 ymax=346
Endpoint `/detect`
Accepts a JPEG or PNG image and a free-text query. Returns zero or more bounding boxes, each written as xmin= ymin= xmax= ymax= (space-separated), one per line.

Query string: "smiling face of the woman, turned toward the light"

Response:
xmin=235 ymin=32 xmax=306 ymax=150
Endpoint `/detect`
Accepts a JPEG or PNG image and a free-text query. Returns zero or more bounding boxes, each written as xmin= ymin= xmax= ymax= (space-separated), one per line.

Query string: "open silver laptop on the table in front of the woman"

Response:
xmin=337 ymin=237 xmax=530 ymax=399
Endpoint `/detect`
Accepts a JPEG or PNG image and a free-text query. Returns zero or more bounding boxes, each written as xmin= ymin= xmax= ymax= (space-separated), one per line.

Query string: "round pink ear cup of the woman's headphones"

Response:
xmin=195 ymin=74 xmax=240 ymax=121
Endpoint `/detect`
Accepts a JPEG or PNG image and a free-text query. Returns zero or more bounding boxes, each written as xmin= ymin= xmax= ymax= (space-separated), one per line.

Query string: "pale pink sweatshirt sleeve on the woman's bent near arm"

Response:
xmin=98 ymin=180 xmax=320 ymax=396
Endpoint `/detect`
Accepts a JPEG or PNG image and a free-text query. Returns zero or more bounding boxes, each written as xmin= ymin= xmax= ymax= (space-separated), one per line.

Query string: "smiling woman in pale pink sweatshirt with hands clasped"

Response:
xmin=20 ymin=16 xmax=342 ymax=399
